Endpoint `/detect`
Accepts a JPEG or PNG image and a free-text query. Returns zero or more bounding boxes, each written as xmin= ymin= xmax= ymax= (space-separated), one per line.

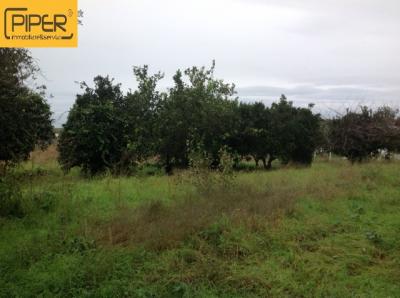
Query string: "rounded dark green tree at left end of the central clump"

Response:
xmin=58 ymin=76 xmax=127 ymax=175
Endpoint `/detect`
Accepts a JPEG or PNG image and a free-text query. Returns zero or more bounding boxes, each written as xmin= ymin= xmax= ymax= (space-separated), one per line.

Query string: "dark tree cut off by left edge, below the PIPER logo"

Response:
xmin=0 ymin=48 xmax=53 ymax=170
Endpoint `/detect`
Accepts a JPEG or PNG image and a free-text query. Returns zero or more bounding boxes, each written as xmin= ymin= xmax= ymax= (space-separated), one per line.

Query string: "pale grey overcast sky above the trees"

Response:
xmin=33 ymin=0 xmax=400 ymax=124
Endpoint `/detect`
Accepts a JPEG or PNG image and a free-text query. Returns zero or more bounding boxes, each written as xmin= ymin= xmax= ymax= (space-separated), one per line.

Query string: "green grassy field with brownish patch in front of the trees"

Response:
xmin=0 ymin=148 xmax=400 ymax=297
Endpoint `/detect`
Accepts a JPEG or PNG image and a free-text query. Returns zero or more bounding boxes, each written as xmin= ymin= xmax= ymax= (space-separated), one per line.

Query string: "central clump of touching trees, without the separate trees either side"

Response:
xmin=58 ymin=65 xmax=321 ymax=174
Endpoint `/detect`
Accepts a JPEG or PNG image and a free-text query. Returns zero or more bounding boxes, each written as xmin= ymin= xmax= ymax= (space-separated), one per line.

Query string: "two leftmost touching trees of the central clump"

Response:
xmin=58 ymin=66 xmax=163 ymax=175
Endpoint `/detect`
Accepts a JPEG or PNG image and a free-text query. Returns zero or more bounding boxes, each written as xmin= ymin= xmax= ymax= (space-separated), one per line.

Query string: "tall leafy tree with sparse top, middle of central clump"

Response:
xmin=159 ymin=63 xmax=237 ymax=170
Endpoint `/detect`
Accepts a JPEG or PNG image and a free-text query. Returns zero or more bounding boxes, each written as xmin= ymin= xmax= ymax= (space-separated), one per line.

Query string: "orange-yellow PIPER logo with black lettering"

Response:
xmin=0 ymin=0 xmax=78 ymax=48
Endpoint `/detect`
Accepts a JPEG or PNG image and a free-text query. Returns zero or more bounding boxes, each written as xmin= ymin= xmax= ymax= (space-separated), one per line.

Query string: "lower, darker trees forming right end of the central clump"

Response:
xmin=231 ymin=95 xmax=320 ymax=168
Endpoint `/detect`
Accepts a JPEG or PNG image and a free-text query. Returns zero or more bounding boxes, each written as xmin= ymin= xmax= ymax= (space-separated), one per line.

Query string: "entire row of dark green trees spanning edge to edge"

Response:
xmin=0 ymin=49 xmax=400 ymax=174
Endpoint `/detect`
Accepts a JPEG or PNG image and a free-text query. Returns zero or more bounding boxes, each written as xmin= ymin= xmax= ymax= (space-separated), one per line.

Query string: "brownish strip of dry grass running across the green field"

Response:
xmin=91 ymin=166 xmax=358 ymax=250
